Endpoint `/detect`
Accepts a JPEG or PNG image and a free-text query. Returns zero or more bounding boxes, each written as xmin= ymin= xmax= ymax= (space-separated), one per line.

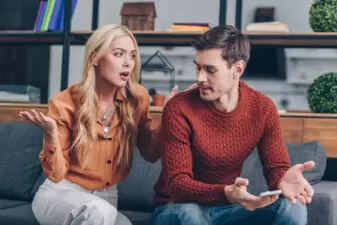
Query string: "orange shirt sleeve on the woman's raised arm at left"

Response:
xmin=40 ymin=100 xmax=71 ymax=182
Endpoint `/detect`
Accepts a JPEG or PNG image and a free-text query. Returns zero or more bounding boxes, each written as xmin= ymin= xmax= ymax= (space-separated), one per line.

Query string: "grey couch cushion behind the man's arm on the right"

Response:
xmin=241 ymin=141 xmax=326 ymax=194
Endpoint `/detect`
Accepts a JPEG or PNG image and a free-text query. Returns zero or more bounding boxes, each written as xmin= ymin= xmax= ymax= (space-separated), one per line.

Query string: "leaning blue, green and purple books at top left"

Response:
xmin=34 ymin=0 xmax=77 ymax=31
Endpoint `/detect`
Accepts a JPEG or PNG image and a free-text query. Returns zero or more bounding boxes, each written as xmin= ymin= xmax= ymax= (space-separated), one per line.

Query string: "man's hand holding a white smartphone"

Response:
xmin=225 ymin=177 xmax=280 ymax=210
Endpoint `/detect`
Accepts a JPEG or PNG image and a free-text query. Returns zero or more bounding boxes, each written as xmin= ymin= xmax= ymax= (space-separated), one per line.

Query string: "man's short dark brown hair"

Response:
xmin=193 ymin=25 xmax=250 ymax=67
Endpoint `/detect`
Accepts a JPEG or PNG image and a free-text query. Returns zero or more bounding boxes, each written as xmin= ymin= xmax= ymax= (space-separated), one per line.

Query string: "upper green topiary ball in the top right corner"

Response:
xmin=309 ymin=0 xmax=337 ymax=32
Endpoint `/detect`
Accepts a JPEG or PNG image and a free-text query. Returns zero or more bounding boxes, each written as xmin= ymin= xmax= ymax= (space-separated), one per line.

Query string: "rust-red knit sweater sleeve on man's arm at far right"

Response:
xmin=258 ymin=102 xmax=291 ymax=190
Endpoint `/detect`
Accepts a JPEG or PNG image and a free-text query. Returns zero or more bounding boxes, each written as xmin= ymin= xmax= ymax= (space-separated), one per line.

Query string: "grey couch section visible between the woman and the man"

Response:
xmin=118 ymin=150 xmax=161 ymax=212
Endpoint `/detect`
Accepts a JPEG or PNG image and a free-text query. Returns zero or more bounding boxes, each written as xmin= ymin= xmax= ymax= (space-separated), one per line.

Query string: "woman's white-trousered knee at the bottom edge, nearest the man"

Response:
xmin=66 ymin=200 xmax=117 ymax=225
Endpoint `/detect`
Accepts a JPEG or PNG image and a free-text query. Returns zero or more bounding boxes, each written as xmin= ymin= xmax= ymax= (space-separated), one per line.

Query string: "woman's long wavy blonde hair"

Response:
xmin=72 ymin=24 xmax=140 ymax=169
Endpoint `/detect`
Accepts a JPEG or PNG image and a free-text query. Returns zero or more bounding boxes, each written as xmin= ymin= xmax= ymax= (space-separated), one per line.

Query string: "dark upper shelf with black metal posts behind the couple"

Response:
xmin=0 ymin=0 xmax=337 ymax=103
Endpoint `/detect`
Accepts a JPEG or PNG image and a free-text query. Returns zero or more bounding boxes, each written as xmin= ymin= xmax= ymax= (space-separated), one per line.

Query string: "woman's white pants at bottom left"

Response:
xmin=32 ymin=179 xmax=132 ymax=225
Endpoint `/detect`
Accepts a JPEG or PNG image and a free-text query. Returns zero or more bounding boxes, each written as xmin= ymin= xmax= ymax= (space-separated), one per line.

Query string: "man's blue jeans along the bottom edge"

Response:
xmin=151 ymin=197 xmax=307 ymax=225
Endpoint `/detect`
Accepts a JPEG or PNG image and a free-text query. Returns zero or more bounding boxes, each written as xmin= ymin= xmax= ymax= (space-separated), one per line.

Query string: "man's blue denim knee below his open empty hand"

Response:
xmin=276 ymin=198 xmax=307 ymax=225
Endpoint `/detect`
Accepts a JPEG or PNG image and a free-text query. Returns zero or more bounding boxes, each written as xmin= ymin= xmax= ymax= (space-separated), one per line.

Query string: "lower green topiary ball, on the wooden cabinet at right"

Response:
xmin=307 ymin=73 xmax=337 ymax=113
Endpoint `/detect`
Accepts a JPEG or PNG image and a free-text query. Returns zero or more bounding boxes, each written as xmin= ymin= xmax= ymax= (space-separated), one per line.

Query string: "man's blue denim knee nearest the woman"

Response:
xmin=152 ymin=203 xmax=209 ymax=225
